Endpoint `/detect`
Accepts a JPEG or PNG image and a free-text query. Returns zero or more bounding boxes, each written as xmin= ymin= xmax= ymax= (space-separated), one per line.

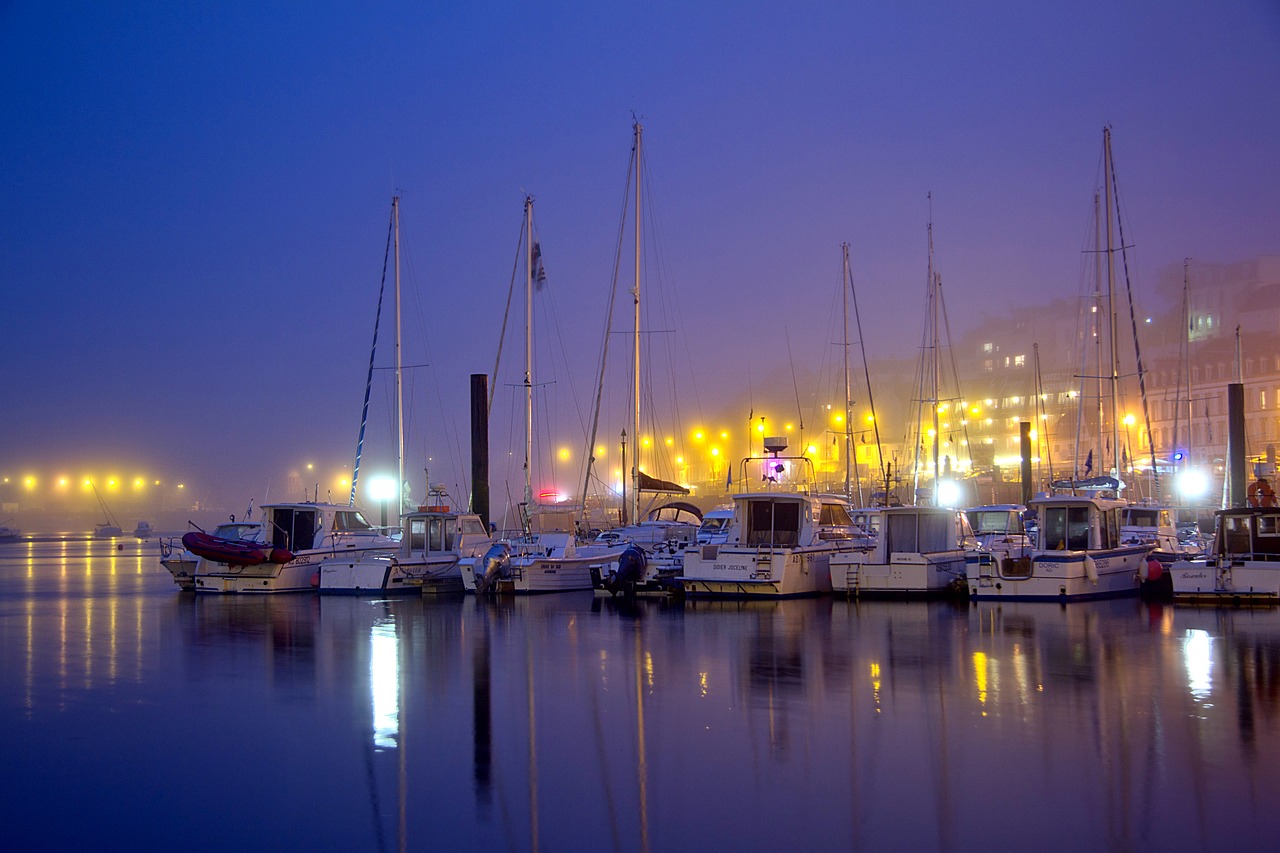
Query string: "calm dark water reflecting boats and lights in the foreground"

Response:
xmin=0 ymin=540 xmax=1280 ymax=850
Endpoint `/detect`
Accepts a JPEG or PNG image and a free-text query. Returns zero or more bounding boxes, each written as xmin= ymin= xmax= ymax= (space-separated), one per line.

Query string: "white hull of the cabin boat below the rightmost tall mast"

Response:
xmin=966 ymin=547 xmax=1147 ymax=601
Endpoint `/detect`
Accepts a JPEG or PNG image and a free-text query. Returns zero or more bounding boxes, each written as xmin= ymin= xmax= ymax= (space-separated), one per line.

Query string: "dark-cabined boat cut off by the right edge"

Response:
xmin=1169 ymin=507 xmax=1280 ymax=605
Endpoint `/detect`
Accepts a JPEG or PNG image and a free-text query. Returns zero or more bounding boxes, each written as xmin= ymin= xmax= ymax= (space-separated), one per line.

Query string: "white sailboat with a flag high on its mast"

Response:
xmin=458 ymin=196 xmax=620 ymax=594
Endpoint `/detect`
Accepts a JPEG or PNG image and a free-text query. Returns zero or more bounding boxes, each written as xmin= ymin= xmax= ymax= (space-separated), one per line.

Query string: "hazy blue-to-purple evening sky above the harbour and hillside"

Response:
xmin=0 ymin=0 xmax=1280 ymax=521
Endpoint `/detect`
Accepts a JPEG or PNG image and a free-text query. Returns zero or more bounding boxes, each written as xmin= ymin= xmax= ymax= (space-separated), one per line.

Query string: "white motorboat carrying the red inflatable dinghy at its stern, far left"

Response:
xmin=195 ymin=501 xmax=399 ymax=594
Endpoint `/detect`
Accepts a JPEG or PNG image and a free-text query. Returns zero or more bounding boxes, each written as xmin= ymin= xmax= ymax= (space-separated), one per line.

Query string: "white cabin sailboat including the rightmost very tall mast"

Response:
xmin=968 ymin=128 xmax=1152 ymax=602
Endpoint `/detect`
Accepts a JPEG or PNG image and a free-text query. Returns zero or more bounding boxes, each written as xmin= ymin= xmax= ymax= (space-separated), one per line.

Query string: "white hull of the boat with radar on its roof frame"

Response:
xmin=680 ymin=546 xmax=837 ymax=598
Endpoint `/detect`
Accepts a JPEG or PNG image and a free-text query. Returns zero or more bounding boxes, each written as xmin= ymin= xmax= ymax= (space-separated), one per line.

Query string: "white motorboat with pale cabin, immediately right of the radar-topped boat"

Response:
xmin=831 ymin=506 xmax=977 ymax=597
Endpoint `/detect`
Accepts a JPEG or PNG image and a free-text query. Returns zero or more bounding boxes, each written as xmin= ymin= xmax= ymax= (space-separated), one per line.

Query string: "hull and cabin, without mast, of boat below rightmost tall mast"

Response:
xmin=968 ymin=494 xmax=1151 ymax=601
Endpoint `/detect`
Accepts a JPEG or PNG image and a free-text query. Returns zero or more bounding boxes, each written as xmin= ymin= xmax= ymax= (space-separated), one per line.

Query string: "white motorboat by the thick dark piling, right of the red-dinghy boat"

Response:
xmin=320 ymin=505 xmax=493 ymax=594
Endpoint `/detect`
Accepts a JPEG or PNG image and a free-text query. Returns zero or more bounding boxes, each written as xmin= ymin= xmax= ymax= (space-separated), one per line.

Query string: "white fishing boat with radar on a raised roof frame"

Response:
xmin=680 ymin=437 xmax=855 ymax=598
